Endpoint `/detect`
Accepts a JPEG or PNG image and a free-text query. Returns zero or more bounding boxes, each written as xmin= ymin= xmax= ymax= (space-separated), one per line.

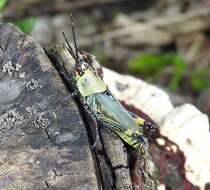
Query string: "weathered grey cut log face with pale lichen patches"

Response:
xmin=0 ymin=24 xmax=98 ymax=190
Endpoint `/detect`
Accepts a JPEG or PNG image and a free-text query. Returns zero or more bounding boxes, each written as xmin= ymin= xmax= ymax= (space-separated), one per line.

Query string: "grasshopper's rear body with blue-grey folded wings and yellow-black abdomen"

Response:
xmin=85 ymin=91 xmax=147 ymax=148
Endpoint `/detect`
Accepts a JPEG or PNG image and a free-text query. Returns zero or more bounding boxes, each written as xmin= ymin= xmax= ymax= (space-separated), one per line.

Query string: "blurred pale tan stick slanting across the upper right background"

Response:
xmin=80 ymin=7 xmax=210 ymax=46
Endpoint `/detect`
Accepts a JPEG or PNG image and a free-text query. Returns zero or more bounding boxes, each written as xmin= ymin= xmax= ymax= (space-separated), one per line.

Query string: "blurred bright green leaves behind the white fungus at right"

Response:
xmin=128 ymin=53 xmax=210 ymax=92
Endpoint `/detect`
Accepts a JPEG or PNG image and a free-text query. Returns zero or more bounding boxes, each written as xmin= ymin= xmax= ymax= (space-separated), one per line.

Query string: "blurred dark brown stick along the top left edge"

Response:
xmin=2 ymin=0 xmax=128 ymax=19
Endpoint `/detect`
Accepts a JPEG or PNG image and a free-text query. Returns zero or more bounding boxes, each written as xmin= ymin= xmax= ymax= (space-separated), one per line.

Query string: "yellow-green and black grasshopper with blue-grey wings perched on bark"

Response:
xmin=47 ymin=17 xmax=158 ymax=153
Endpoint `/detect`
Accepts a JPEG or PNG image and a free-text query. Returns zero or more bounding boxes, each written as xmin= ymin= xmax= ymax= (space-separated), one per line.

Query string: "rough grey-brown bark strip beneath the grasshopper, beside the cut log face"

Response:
xmin=47 ymin=47 xmax=157 ymax=190
